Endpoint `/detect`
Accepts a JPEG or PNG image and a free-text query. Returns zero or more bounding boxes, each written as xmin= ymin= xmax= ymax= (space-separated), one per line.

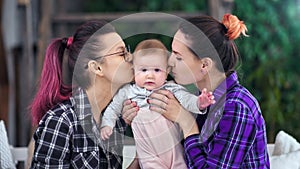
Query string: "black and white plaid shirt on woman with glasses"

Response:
xmin=31 ymin=89 xmax=126 ymax=169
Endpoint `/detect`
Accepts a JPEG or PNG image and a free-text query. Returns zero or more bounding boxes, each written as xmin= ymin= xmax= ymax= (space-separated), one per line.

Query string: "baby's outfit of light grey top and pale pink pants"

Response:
xmin=101 ymin=82 xmax=203 ymax=169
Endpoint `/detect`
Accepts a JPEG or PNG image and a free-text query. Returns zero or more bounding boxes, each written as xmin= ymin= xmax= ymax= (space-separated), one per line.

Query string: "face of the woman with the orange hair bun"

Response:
xmin=169 ymin=30 xmax=203 ymax=85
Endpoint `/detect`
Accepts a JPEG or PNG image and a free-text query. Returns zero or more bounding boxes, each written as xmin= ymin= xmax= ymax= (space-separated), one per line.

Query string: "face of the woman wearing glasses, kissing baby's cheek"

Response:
xmin=101 ymin=33 xmax=133 ymax=84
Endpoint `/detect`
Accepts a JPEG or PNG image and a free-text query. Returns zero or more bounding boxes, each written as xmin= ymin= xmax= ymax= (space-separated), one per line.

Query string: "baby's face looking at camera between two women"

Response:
xmin=133 ymin=53 xmax=168 ymax=90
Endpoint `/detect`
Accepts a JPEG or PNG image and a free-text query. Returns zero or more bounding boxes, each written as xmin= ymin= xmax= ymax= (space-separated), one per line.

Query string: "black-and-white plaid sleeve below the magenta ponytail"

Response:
xmin=31 ymin=113 xmax=72 ymax=168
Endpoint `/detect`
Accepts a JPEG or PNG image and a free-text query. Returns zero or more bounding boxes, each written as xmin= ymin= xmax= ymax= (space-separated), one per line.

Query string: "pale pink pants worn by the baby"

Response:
xmin=131 ymin=108 xmax=187 ymax=169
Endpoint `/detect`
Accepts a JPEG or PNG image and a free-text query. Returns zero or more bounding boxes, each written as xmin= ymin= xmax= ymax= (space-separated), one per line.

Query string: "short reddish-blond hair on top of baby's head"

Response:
xmin=134 ymin=39 xmax=169 ymax=59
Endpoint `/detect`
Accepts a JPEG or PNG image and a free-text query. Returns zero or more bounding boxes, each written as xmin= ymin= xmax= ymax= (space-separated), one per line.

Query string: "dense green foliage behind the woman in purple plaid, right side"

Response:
xmin=233 ymin=0 xmax=300 ymax=142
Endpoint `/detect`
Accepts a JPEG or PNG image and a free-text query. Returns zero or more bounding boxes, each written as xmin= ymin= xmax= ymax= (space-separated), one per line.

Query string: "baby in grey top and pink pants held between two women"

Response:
xmin=101 ymin=39 xmax=214 ymax=169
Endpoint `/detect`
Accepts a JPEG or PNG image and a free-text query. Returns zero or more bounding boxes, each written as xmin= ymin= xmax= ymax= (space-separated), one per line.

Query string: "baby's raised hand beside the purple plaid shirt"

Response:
xmin=197 ymin=88 xmax=216 ymax=110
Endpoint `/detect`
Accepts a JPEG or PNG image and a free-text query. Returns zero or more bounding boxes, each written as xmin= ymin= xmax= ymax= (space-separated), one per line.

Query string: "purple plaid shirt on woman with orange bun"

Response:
xmin=184 ymin=72 xmax=270 ymax=168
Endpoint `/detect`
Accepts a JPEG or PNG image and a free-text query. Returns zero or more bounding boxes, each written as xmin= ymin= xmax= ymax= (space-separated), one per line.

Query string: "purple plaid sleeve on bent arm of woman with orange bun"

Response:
xmin=184 ymin=102 xmax=257 ymax=168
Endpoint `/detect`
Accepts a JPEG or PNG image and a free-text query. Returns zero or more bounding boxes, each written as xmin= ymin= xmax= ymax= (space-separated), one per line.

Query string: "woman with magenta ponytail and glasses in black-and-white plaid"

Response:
xmin=30 ymin=20 xmax=138 ymax=168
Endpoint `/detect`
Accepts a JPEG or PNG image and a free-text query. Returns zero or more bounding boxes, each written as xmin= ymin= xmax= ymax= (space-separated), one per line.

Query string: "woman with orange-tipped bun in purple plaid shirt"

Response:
xmin=124 ymin=14 xmax=270 ymax=168
